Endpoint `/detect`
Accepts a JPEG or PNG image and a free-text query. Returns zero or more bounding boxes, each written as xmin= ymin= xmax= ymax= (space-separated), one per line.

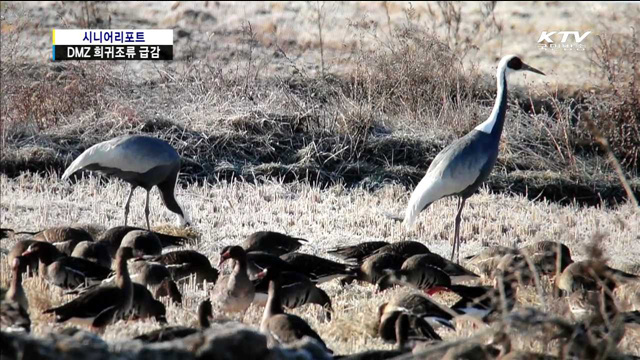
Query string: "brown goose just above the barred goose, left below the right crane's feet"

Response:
xmin=376 ymin=261 xmax=451 ymax=295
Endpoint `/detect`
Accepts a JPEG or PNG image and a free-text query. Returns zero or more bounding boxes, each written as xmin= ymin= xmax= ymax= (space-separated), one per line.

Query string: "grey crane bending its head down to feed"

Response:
xmin=62 ymin=135 xmax=191 ymax=230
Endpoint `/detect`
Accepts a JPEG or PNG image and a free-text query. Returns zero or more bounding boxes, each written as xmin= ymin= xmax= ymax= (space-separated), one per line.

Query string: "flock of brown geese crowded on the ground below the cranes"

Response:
xmin=1 ymin=226 xmax=640 ymax=359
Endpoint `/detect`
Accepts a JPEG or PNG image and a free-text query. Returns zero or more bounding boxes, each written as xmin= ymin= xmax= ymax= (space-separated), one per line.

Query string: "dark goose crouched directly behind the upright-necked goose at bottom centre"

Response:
xmin=253 ymin=268 xmax=333 ymax=321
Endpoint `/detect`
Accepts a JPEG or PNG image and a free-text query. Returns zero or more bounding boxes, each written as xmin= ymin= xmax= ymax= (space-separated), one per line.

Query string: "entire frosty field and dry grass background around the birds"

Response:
xmin=0 ymin=2 xmax=640 ymax=354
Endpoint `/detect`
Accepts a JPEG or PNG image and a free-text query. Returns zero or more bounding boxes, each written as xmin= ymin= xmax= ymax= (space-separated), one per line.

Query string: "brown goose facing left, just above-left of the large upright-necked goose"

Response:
xmin=23 ymin=241 xmax=111 ymax=289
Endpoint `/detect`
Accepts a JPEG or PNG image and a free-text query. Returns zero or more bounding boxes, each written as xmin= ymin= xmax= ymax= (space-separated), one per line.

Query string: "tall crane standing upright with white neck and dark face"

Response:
xmin=404 ymin=55 xmax=544 ymax=263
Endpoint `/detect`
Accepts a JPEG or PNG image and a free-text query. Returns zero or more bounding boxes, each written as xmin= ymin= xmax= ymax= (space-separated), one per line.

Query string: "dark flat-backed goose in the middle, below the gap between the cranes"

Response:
xmin=280 ymin=252 xmax=357 ymax=284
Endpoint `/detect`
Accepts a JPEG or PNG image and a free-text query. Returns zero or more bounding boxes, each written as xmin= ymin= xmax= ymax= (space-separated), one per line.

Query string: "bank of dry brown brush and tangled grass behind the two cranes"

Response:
xmin=1 ymin=3 xmax=640 ymax=205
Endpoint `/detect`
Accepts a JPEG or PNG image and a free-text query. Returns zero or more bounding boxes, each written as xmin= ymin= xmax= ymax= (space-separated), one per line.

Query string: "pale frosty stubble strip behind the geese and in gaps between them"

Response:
xmin=0 ymin=175 xmax=640 ymax=354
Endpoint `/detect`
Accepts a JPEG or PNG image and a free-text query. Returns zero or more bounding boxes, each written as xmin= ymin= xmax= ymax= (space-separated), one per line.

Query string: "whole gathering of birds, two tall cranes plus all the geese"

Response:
xmin=0 ymin=56 xmax=640 ymax=359
